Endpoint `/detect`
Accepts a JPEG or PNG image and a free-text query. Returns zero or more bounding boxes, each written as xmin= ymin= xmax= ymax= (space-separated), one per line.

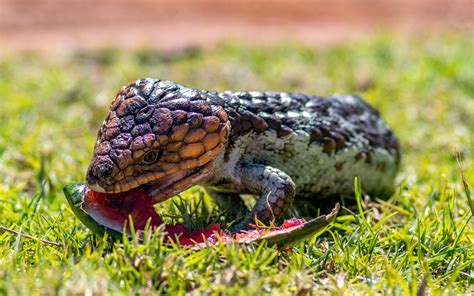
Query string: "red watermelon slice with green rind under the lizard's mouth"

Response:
xmin=64 ymin=183 xmax=339 ymax=249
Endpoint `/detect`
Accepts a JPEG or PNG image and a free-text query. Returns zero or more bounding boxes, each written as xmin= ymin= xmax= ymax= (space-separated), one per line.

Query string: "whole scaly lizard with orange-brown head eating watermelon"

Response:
xmin=86 ymin=79 xmax=400 ymax=231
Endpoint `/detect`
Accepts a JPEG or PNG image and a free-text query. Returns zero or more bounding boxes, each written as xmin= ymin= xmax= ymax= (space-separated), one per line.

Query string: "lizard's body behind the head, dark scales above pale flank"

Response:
xmin=219 ymin=92 xmax=400 ymax=198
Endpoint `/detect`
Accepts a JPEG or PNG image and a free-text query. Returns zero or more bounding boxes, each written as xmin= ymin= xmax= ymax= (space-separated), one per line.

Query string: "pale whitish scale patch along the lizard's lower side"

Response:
xmin=221 ymin=130 xmax=396 ymax=198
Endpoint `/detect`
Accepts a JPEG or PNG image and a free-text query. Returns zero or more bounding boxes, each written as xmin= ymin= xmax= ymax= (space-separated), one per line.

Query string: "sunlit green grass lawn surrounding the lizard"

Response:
xmin=0 ymin=34 xmax=474 ymax=295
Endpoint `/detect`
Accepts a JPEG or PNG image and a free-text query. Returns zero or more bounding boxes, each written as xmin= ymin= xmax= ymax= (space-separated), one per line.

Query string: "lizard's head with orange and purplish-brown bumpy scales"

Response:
xmin=86 ymin=79 xmax=230 ymax=202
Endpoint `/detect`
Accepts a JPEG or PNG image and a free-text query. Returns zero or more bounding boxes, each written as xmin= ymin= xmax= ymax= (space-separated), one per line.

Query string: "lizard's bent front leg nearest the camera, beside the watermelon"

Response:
xmin=231 ymin=164 xmax=295 ymax=232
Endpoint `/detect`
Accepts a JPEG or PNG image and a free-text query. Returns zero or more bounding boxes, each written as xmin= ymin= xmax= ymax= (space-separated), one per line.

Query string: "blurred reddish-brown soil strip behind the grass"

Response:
xmin=0 ymin=0 xmax=474 ymax=51
